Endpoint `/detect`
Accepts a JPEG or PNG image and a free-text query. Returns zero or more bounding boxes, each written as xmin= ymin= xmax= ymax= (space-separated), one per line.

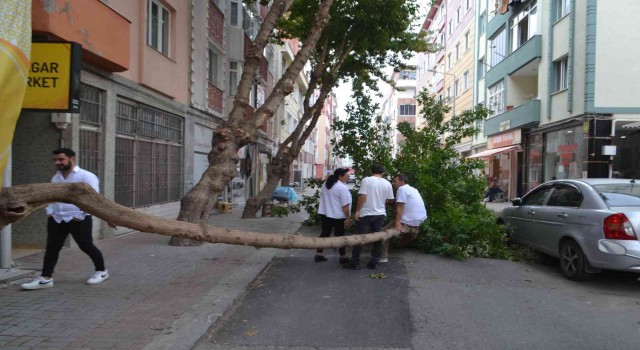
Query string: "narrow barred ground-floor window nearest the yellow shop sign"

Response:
xmin=78 ymin=84 xmax=105 ymax=178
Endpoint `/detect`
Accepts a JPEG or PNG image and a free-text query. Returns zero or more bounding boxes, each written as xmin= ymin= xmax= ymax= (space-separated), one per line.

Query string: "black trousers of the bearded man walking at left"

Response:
xmin=42 ymin=215 xmax=105 ymax=277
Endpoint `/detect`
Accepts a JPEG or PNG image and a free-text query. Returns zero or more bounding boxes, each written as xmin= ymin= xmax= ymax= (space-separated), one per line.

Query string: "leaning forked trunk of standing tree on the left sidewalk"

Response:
xmin=169 ymin=0 xmax=333 ymax=245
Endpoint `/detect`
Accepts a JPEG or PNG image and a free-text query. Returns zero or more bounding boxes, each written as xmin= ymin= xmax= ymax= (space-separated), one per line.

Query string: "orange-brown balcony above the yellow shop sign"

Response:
xmin=31 ymin=0 xmax=131 ymax=72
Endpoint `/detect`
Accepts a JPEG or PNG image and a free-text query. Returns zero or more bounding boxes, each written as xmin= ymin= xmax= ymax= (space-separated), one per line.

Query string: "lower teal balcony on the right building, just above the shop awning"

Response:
xmin=484 ymin=100 xmax=540 ymax=136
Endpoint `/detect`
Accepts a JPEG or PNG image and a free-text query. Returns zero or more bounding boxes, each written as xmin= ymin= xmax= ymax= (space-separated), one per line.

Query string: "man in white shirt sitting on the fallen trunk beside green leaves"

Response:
xmin=380 ymin=174 xmax=427 ymax=263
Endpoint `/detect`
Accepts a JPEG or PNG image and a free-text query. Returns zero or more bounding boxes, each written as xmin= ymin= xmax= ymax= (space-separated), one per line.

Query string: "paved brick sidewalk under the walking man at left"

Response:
xmin=0 ymin=207 xmax=304 ymax=349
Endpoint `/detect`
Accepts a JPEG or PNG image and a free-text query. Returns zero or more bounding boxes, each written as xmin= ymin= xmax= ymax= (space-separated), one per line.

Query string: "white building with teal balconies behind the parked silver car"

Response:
xmin=472 ymin=0 xmax=640 ymax=198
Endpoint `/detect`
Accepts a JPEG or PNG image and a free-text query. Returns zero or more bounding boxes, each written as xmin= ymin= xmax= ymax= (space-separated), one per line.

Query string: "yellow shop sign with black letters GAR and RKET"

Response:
xmin=22 ymin=42 xmax=82 ymax=113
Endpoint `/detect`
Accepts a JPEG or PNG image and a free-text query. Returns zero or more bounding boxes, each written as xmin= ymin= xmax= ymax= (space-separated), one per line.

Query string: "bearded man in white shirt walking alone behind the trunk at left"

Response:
xmin=21 ymin=148 xmax=109 ymax=289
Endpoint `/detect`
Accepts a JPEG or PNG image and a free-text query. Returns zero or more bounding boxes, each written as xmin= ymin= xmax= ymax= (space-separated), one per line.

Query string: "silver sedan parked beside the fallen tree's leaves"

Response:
xmin=498 ymin=179 xmax=640 ymax=280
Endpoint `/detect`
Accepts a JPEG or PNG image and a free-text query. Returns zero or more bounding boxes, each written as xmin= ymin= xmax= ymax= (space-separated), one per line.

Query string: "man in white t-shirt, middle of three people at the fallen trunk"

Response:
xmin=342 ymin=164 xmax=393 ymax=270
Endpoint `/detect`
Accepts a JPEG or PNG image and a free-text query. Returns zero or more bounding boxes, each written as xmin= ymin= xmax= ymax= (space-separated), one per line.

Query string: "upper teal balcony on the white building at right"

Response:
xmin=486 ymin=35 xmax=542 ymax=86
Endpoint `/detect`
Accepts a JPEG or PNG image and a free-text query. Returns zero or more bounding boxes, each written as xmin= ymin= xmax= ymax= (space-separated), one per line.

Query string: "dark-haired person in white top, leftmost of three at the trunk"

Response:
xmin=315 ymin=168 xmax=352 ymax=264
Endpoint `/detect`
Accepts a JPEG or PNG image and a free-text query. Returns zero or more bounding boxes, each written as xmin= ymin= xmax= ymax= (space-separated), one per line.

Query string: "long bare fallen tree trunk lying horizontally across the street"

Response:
xmin=0 ymin=183 xmax=400 ymax=249
